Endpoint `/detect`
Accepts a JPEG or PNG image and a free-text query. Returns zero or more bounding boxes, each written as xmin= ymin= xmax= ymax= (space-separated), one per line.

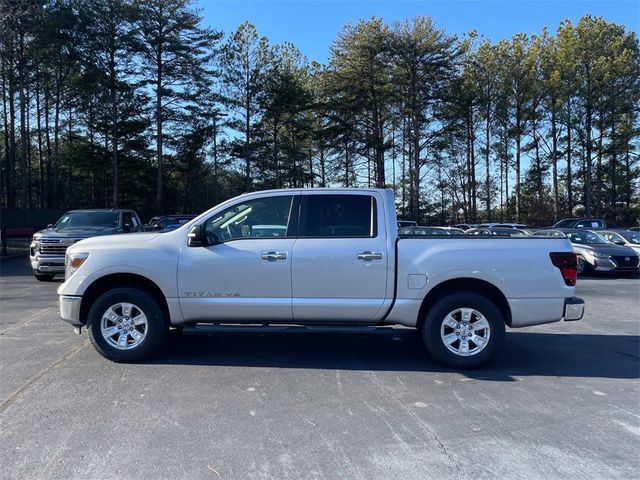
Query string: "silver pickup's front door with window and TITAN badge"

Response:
xmin=178 ymin=194 xmax=299 ymax=322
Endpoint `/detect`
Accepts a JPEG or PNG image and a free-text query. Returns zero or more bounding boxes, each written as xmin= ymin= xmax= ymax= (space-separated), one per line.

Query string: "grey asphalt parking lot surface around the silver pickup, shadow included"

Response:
xmin=0 ymin=257 xmax=640 ymax=480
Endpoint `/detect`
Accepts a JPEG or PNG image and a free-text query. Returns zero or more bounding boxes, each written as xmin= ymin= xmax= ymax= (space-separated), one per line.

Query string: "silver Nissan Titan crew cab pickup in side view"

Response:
xmin=58 ymin=189 xmax=584 ymax=368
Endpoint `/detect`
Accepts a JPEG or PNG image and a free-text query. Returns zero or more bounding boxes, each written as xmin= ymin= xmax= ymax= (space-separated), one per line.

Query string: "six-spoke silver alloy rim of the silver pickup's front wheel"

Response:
xmin=100 ymin=302 xmax=147 ymax=350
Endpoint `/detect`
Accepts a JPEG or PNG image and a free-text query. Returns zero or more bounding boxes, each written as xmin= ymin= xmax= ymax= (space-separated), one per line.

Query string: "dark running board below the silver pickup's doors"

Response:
xmin=182 ymin=323 xmax=397 ymax=335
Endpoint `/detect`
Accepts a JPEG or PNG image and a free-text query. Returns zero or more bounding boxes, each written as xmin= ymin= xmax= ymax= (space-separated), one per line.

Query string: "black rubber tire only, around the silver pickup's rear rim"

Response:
xmin=420 ymin=292 xmax=505 ymax=370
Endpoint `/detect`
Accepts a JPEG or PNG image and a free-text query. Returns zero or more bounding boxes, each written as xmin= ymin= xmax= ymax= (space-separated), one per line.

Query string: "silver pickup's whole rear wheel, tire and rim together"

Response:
xmin=421 ymin=292 xmax=505 ymax=369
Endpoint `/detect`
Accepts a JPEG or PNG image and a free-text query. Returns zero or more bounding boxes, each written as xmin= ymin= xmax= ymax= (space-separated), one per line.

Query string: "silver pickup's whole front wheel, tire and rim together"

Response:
xmin=87 ymin=288 xmax=169 ymax=362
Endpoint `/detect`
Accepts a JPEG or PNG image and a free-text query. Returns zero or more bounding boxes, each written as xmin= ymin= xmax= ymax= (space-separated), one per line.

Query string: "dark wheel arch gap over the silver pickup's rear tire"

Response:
xmin=416 ymin=278 xmax=511 ymax=328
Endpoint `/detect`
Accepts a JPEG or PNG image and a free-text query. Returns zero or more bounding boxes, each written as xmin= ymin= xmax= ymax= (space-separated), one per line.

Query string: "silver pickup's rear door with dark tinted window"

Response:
xmin=291 ymin=192 xmax=392 ymax=323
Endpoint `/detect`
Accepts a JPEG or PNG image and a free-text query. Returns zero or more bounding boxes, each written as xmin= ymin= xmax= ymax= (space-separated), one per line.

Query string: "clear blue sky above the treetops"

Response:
xmin=196 ymin=0 xmax=640 ymax=62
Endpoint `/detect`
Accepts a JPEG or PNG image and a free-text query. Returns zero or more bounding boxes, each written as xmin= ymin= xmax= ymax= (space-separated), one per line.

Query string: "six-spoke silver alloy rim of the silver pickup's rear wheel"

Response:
xmin=440 ymin=308 xmax=491 ymax=357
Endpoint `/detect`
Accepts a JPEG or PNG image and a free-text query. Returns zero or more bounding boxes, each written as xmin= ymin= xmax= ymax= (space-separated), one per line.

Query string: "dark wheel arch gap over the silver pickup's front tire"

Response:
xmin=80 ymin=273 xmax=170 ymax=325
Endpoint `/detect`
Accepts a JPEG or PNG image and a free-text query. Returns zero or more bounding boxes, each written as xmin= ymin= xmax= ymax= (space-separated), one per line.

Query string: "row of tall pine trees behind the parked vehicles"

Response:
xmin=0 ymin=0 xmax=640 ymax=225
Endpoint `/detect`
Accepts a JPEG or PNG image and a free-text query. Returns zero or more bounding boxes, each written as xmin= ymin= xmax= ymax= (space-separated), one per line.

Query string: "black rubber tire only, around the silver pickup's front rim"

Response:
xmin=87 ymin=287 xmax=169 ymax=363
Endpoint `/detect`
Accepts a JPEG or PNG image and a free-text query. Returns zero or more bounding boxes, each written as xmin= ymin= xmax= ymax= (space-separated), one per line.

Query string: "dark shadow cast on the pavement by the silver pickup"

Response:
xmin=148 ymin=329 xmax=640 ymax=381
